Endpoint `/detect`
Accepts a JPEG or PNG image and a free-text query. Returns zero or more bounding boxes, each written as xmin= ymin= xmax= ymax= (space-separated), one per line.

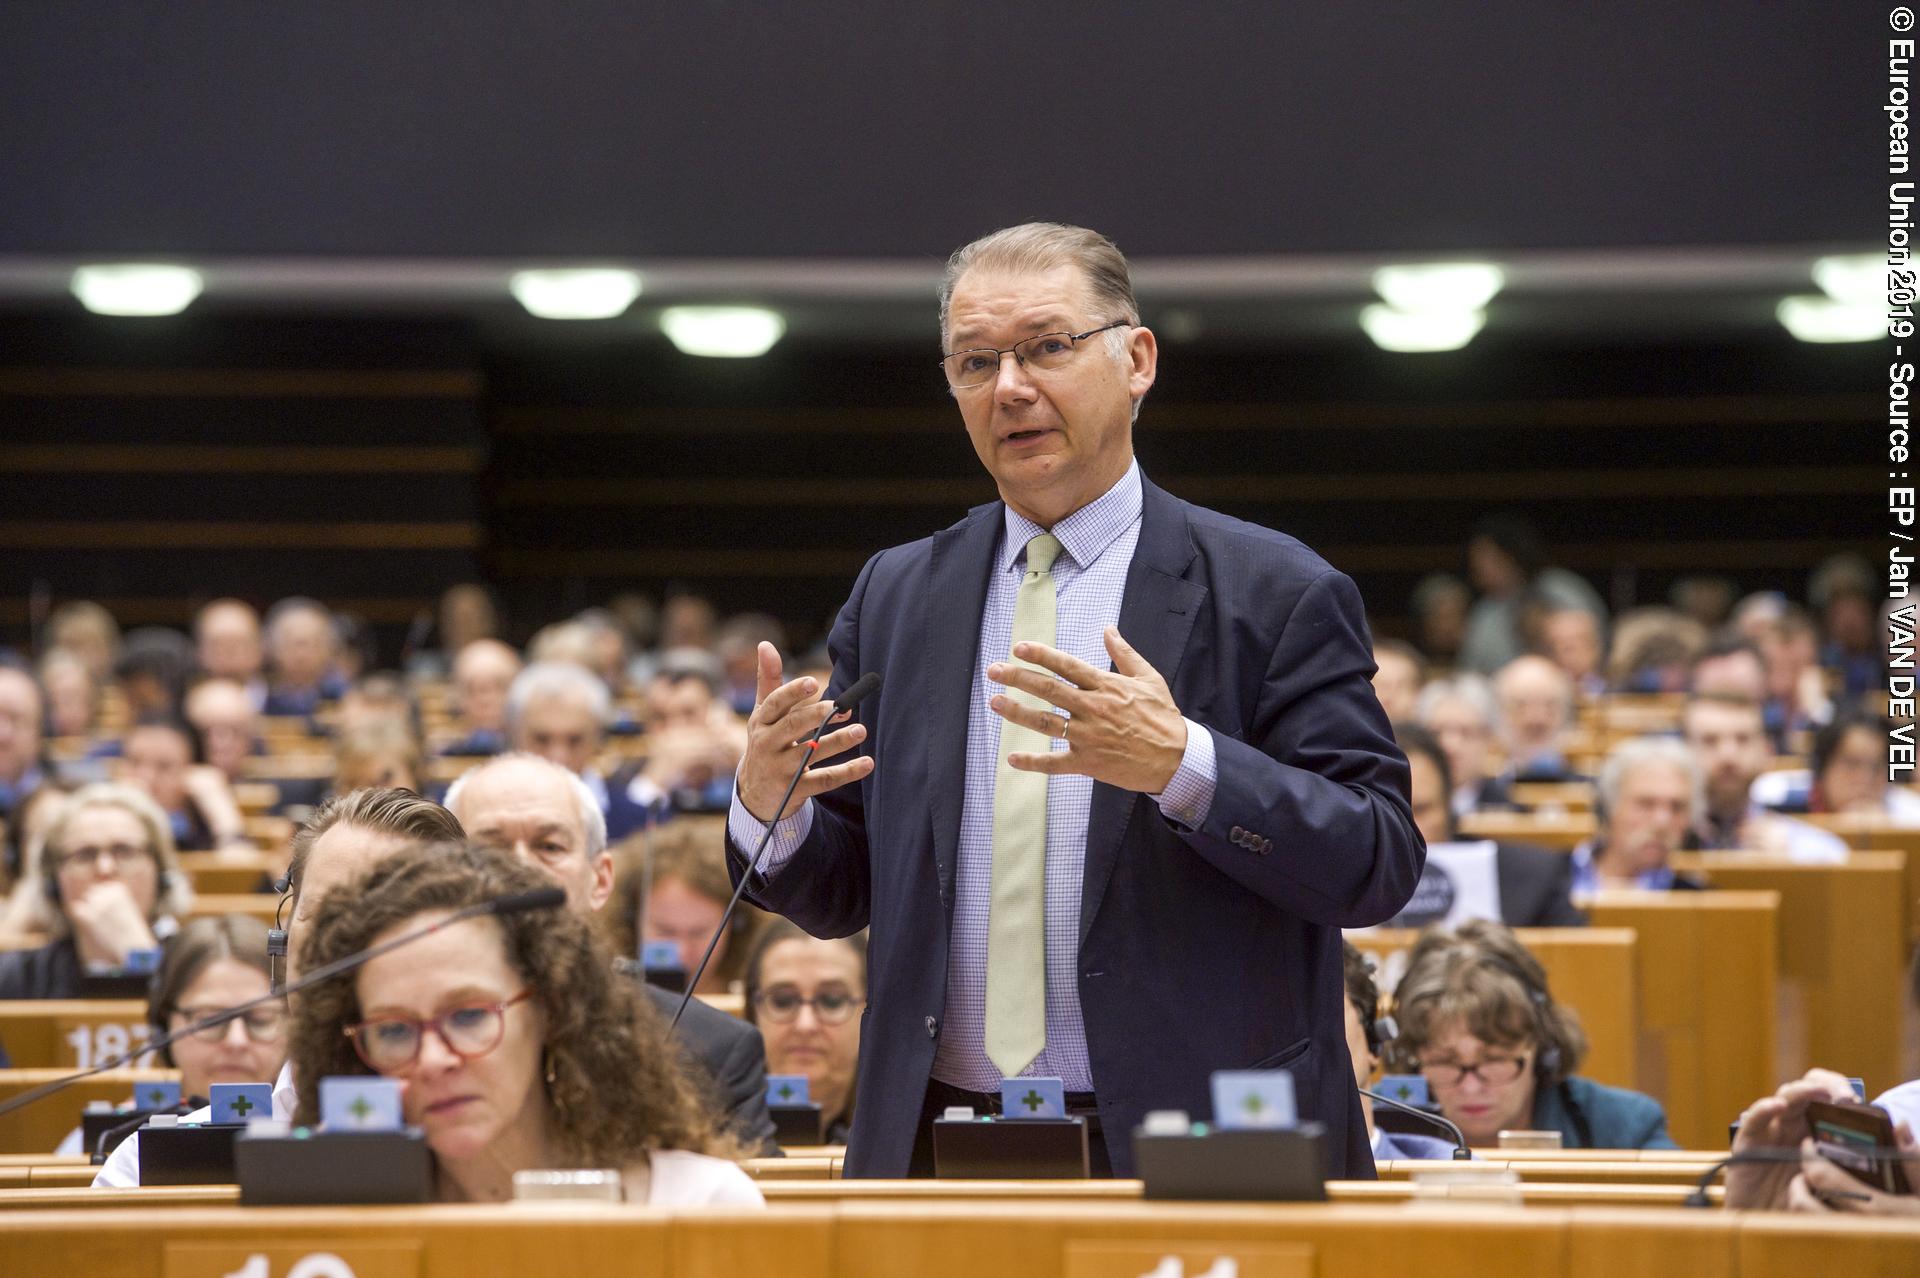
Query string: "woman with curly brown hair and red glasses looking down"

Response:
xmin=292 ymin=844 xmax=762 ymax=1207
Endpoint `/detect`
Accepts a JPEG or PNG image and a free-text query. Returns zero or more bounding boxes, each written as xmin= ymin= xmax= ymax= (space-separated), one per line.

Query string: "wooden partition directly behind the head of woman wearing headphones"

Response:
xmin=1348 ymin=927 xmax=1640 ymax=1088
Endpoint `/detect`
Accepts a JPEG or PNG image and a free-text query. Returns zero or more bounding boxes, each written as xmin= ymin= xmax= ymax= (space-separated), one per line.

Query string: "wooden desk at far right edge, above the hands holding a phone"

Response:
xmin=1674 ymin=852 xmax=1914 ymax=1100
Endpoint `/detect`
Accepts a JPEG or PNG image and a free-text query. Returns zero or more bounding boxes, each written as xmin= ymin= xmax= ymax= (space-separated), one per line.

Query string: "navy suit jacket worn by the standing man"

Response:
xmin=728 ymin=475 xmax=1427 ymax=1176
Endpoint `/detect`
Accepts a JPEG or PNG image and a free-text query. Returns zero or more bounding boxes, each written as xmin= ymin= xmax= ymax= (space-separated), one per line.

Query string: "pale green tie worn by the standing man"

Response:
xmin=985 ymin=533 xmax=1060 ymax=1078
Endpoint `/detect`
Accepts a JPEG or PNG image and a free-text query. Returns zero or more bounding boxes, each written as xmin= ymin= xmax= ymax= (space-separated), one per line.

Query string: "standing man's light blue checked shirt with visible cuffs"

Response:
xmin=728 ymin=462 xmax=1219 ymax=1092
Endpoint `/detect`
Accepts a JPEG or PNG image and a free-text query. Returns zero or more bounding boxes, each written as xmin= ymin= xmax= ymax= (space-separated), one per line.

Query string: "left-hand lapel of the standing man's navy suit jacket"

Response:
xmin=924 ymin=503 xmax=1004 ymax=913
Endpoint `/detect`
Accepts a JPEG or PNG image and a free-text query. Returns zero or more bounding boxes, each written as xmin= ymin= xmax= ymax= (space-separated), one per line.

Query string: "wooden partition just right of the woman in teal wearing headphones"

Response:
xmin=1588 ymin=890 xmax=1780 ymax=1149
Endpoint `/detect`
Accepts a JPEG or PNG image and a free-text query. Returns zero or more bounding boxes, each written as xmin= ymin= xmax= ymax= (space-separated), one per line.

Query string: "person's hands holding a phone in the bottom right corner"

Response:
xmin=1726 ymin=1069 xmax=1920 ymax=1219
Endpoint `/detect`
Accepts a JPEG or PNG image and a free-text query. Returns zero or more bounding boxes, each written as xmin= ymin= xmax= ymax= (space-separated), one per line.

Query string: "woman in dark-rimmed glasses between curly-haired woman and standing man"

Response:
xmin=747 ymin=919 xmax=866 ymax=1146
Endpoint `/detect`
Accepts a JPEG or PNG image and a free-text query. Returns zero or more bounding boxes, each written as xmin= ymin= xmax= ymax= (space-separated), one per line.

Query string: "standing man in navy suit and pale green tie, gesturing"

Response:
xmin=728 ymin=223 xmax=1423 ymax=1176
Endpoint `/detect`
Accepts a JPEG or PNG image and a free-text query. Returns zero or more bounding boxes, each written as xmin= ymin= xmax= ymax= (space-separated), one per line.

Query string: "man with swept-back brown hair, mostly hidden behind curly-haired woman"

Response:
xmin=94 ymin=791 xmax=463 ymax=1190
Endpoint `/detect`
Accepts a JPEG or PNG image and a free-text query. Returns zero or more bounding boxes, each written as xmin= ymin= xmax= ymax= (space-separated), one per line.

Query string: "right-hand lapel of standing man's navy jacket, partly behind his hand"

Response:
xmin=1079 ymin=476 xmax=1208 ymax=946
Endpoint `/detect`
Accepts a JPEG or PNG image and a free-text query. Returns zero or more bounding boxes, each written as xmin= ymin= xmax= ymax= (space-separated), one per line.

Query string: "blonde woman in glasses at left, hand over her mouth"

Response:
xmin=0 ymin=783 xmax=192 ymax=998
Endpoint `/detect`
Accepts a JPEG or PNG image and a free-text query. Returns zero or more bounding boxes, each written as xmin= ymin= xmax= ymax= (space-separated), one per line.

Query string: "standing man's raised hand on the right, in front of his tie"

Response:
xmin=987 ymin=626 xmax=1187 ymax=794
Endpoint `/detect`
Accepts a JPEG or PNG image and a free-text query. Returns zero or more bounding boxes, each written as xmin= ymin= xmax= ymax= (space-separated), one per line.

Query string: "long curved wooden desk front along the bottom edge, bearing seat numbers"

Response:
xmin=0 ymin=1190 xmax=1920 ymax=1278
